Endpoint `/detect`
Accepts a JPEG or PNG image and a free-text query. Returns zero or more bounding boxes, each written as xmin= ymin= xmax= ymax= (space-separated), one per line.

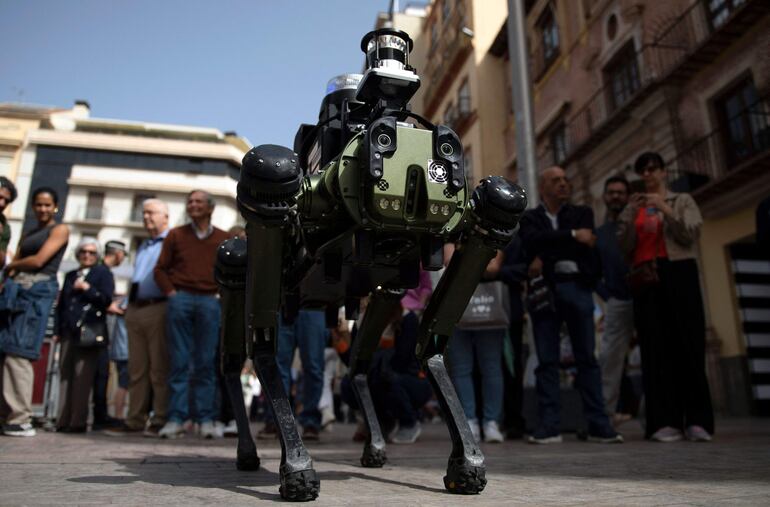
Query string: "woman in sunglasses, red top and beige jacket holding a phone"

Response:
xmin=617 ymin=152 xmax=714 ymax=442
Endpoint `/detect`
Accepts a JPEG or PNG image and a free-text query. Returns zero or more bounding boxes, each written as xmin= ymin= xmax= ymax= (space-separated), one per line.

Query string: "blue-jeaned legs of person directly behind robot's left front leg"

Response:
xmin=257 ymin=309 xmax=329 ymax=440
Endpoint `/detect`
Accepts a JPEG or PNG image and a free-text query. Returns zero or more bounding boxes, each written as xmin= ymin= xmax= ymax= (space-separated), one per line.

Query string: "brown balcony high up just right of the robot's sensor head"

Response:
xmin=422 ymin=2 xmax=473 ymax=118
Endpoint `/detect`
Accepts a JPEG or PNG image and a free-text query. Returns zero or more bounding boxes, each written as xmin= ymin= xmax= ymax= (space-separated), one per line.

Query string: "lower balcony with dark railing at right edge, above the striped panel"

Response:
xmin=667 ymin=93 xmax=770 ymax=203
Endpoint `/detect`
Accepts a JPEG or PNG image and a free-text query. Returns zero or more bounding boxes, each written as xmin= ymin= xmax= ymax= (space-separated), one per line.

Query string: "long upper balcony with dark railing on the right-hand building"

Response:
xmin=565 ymin=0 xmax=770 ymax=163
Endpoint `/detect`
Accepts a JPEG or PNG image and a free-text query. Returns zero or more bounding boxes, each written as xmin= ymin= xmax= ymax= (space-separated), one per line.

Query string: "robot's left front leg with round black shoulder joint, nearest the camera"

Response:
xmin=238 ymin=145 xmax=320 ymax=501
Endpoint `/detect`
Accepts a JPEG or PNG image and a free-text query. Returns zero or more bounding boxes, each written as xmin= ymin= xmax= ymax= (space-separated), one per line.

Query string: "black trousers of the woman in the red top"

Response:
xmin=634 ymin=259 xmax=714 ymax=438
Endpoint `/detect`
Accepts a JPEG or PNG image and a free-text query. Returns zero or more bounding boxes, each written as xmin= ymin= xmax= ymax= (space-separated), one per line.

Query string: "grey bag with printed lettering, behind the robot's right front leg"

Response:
xmin=457 ymin=281 xmax=511 ymax=329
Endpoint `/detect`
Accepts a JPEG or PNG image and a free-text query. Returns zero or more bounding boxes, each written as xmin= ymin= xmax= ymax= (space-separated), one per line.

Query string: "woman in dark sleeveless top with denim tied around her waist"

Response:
xmin=0 ymin=187 xmax=69 ymax=437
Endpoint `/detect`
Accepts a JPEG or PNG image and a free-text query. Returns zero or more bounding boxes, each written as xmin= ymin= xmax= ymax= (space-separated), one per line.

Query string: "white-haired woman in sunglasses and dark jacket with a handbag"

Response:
xmin=56 ymin=237 xmax=115 ymax=433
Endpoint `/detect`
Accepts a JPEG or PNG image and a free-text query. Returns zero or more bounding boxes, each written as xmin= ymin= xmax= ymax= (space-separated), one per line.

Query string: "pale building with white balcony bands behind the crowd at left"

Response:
xmin=0 ymin=102 xmax=250 ymax=290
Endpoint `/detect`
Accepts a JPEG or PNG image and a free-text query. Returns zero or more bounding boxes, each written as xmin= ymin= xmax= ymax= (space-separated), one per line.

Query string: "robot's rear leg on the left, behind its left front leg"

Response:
xmin=214 ymin=238 xmax=260 ymax=470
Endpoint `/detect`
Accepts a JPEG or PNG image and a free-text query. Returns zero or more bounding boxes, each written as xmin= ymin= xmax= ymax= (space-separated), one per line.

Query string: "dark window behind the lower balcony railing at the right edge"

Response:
xmin=716 ymin=78 xmax=770 ymax=167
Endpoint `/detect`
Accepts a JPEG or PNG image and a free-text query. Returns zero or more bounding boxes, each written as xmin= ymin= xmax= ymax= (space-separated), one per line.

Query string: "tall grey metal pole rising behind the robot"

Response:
xmin=508 ymin=0 xmax=540 ymax=208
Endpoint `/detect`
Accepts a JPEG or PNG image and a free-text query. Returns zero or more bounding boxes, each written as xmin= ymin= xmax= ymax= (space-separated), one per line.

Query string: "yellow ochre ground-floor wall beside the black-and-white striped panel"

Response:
xmin=700 ymin=204 xmax=756 ymax=357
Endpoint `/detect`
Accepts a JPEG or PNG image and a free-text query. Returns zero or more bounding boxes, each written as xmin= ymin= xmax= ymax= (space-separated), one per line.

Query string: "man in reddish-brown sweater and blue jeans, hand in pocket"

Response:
xmin=154 ymin=190 xmax=228 ymax=438
